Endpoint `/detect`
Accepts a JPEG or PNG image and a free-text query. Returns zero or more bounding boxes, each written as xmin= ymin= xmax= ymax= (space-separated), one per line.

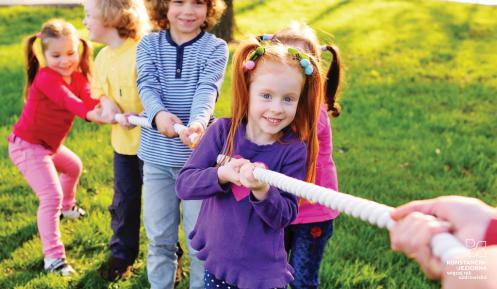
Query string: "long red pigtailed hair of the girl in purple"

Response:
xmin=223 ymin=39 xmax=323 ymax=182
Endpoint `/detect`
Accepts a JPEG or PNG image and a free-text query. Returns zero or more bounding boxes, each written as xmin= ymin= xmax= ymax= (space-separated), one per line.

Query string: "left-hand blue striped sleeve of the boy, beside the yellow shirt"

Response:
xmin=136 ymin=34 xmax=167 ymax=124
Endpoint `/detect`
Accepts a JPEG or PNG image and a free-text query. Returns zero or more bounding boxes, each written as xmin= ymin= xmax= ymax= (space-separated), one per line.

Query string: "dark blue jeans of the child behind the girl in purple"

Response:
xmin=285 ymin=220 xmax=333 ymax=289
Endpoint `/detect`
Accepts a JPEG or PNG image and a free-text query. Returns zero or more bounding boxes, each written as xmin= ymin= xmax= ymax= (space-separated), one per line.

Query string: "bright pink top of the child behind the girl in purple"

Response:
xmin=292 ymin=106 xmax=340 ymax=224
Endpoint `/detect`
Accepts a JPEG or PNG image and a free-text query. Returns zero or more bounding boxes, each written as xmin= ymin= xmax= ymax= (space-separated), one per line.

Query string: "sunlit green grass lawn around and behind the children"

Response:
xmin=0 ymin=0 xmax=497 ymax=288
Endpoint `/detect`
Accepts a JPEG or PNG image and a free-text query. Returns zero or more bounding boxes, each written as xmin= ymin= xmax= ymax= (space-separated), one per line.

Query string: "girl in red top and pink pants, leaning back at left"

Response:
xmin=8 ymin=19 xmax=103 ymax=275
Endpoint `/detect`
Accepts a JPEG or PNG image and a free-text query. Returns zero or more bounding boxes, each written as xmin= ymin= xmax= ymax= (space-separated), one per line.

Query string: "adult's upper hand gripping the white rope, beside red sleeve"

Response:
xmin=390 ymin=196 xmax=496 ymax=279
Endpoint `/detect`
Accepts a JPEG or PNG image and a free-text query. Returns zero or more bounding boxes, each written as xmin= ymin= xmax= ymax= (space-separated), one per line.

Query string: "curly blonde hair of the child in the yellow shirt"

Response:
xmin=92 ymin=0 xmax=149 ymax=40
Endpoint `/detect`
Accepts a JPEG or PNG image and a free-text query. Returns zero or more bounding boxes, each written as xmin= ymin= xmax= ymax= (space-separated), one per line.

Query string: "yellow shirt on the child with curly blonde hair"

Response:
xmin=92 ymin=39 xmax=143 ymax=155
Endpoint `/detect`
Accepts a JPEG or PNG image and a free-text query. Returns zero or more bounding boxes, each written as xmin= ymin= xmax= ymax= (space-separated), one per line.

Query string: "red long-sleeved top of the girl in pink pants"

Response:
xmin=14 ymin=67 xmax=99 ymax=152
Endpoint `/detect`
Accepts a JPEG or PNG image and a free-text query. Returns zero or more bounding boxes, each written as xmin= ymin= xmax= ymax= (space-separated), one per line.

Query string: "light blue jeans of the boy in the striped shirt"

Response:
xmin=143 ymin=162 xmax=204 ymax=289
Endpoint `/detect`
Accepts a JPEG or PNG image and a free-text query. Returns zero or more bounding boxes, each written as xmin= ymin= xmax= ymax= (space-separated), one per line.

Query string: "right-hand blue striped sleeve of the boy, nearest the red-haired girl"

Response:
xmin=189 ymin=39 xmax=228 ymax=128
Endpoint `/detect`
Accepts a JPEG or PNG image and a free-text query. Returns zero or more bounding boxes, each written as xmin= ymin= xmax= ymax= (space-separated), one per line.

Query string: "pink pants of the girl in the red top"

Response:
xmin=8 ymin=134 xmax=83 ymax=258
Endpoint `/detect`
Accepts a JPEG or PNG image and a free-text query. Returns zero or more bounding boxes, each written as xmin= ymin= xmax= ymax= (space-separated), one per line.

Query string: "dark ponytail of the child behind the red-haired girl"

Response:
xmin=324 ymin=45 xmax=342 ymax=117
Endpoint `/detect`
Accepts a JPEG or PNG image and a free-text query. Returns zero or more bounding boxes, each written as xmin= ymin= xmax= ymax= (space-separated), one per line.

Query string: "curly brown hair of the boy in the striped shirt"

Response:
xmin=145 ymin=0 xmax=226 ymax=30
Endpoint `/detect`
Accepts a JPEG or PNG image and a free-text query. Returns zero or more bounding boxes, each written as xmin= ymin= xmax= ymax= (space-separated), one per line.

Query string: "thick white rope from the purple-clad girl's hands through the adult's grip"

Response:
xmin=217 ymin=155 xmax=468 ymax=262
